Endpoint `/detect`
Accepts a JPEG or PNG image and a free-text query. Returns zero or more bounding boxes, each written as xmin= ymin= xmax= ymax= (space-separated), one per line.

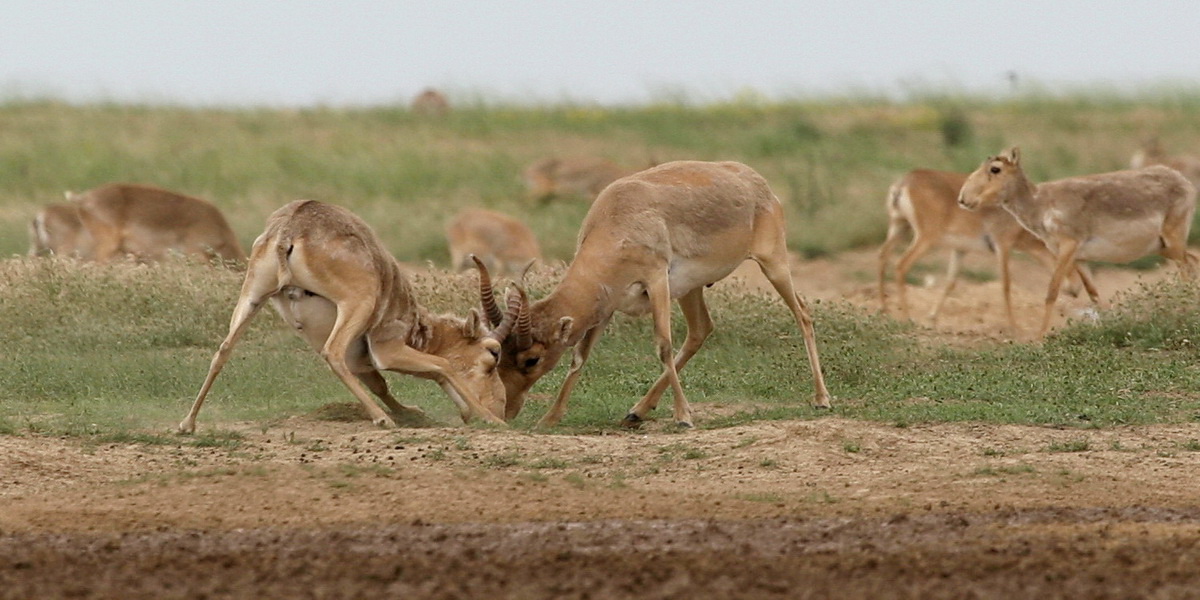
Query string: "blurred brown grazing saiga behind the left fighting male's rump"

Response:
xmin=48 ymin=184 xmax=246 ymax=263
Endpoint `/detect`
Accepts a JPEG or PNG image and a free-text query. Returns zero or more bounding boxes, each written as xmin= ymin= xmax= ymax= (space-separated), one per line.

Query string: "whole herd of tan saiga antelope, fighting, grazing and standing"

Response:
xmin=30 ymin=132 xmax=1200 ymax=433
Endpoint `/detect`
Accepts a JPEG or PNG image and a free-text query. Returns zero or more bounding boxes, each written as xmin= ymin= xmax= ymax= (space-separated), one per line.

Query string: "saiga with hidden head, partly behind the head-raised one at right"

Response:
xmin=878 ymin=169 xmax=1086 ymax=332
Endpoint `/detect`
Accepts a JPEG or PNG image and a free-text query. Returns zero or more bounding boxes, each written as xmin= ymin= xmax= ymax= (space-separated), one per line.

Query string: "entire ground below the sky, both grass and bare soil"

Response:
xmin=0 ymin=92 xmax=1200 ymax=598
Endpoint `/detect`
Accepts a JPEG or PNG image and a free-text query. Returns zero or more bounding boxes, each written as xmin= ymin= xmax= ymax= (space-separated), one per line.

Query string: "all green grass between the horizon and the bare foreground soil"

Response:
xmin=0 ymin=96 xmax=1200 ymax=439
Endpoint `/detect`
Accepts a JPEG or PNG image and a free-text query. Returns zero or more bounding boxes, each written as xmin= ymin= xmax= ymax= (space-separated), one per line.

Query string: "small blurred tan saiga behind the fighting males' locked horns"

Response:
xmin=446 ymin=209 xmax=541 ymax=275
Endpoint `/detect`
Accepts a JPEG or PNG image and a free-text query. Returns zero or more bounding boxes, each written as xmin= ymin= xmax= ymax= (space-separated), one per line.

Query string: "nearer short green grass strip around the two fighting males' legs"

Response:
xmin=0 ymin=253 xmax=1200 ymax=436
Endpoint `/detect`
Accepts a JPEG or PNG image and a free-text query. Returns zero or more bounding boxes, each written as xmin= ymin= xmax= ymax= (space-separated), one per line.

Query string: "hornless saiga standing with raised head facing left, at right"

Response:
xmin=959 ymin=146 xmax=1196 ymax=336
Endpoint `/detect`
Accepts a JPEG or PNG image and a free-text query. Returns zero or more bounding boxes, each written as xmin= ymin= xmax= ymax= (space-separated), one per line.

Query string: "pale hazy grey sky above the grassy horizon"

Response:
xmin=0 ymin=0 xmax=1200 ymax=104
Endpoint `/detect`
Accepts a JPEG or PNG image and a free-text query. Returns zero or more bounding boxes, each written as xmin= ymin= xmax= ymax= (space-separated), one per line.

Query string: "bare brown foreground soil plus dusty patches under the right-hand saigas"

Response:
xmin=0 ymin=252 xmax=1200 ymax=598
